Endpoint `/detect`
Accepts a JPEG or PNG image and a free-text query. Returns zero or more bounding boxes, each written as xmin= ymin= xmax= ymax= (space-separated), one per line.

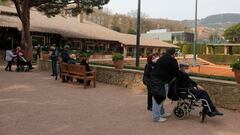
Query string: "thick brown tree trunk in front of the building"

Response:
xmin=21 ymin=3 xmax=32 ymax=60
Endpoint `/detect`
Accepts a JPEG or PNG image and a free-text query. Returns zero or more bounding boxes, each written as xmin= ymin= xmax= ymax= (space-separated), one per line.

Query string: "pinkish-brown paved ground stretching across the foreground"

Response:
xmin=0 ymin=70 xmax=240 ymax=135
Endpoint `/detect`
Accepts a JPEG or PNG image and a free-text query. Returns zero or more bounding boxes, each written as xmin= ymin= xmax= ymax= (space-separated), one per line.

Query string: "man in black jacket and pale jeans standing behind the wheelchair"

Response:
xmin=151 ymin=48 xmax=179 ymax=122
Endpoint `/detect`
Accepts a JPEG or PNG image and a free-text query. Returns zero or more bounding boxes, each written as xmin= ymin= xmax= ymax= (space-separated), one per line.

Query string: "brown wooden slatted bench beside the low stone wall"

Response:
xmin=60 ymin=63 xmax=96 ymax=89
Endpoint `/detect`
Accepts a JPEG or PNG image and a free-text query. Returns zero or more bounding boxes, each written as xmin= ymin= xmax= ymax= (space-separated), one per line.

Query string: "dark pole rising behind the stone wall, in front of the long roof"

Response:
xmin=136 ymin=0 xmax=141 ymax=67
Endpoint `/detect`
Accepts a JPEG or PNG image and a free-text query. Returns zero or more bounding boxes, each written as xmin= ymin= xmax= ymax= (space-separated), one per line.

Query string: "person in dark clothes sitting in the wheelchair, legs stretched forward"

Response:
xmin=176 ymin=63 xmax=224 ymax=117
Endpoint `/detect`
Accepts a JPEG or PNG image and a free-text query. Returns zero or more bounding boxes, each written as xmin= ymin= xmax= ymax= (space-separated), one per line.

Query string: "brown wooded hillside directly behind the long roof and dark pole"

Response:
xmin=85 ymin=10 xmax=191 ymax=34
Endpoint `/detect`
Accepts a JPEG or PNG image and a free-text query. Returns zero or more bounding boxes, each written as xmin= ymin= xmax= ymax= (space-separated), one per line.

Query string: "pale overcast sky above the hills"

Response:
xmin=105 ymin=0 xmax=240 ymax=20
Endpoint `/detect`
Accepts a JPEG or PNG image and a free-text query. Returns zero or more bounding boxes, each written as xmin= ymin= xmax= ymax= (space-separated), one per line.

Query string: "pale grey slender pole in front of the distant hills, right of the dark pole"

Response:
xmin=193 ymin=0 xmax=198 ymax=66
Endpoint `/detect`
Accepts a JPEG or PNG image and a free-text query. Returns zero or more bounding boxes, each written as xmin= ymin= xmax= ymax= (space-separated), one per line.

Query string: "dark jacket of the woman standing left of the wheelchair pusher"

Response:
xmin=143 ymin=63 xmax=154 ymax=85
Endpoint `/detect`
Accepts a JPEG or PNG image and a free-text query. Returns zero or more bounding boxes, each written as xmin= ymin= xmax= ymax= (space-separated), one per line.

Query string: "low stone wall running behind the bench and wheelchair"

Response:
xmin=39 ymin=61 xmax=240 ymax=112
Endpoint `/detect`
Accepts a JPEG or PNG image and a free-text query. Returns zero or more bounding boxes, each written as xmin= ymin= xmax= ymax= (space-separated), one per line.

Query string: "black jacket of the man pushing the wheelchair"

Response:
xmin=151 ymin=54 xmax=179 ymax=83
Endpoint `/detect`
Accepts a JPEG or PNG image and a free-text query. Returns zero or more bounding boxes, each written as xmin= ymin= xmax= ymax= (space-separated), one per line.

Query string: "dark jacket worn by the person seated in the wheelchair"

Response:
xmin=177 ymin=71 xmax=197 ymax=88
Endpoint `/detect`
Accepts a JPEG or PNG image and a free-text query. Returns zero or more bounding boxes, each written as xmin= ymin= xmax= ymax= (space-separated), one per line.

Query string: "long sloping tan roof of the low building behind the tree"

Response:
xmin=0 ymin=6 xmax=178 ymax=48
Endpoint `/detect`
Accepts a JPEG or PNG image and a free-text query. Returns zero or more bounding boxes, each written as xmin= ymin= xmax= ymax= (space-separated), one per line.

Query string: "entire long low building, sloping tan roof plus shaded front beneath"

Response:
xmin=0 ymin=6 xmax=178 ymax=61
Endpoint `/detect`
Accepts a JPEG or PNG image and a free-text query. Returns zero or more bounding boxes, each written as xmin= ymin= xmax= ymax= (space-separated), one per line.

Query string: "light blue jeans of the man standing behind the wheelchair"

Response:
xmin=152 ymin=84 xmax=169 ymax=122
